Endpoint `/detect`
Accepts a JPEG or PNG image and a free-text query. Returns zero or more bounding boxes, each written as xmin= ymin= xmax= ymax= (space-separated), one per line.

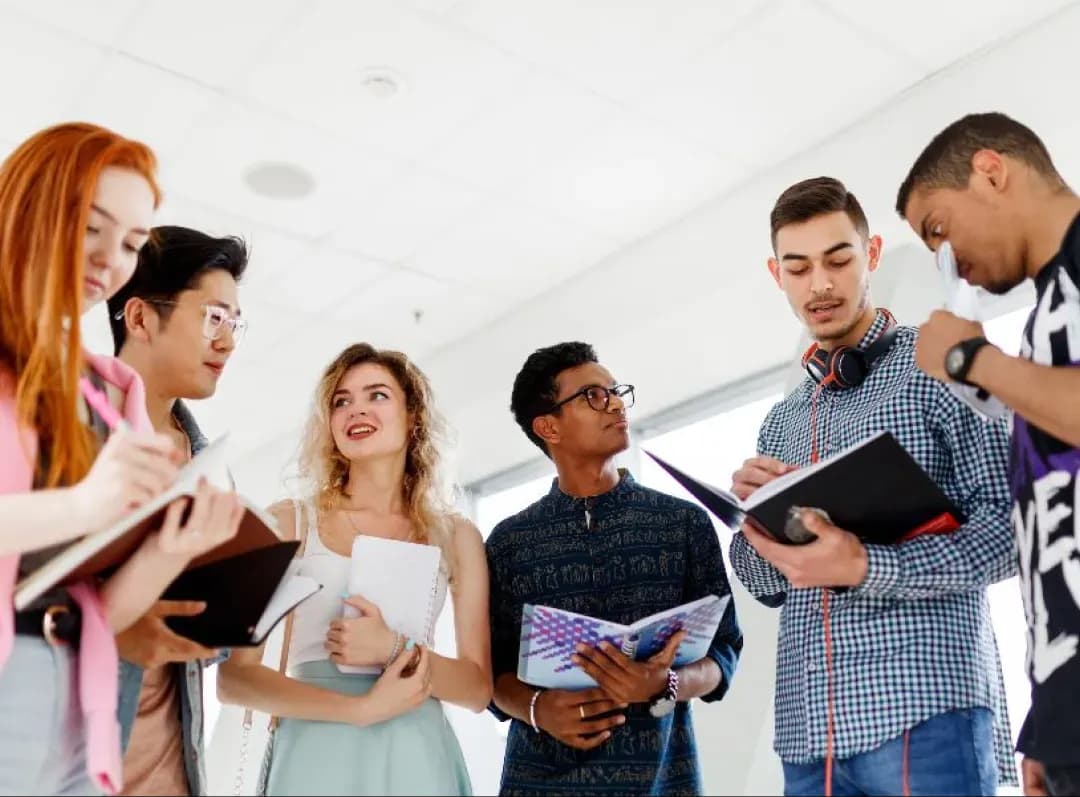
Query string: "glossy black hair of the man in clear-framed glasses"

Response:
xmin=109 ymin=227 xmax=247 ymax=354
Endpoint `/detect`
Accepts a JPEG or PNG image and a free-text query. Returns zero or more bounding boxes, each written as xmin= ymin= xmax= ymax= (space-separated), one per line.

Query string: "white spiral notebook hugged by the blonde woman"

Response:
xmin=337 ymin=535 xmax=443 ymax=675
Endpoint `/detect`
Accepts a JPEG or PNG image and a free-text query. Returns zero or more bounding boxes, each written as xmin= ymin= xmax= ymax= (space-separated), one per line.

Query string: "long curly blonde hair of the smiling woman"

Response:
xmin=298 ymin=343 xmax=455 ymax=580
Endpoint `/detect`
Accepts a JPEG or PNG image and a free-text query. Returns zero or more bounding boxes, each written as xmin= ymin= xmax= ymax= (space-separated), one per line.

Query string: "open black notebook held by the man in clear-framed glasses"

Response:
xmin=162 ymin=541 xmax=322 ymax=648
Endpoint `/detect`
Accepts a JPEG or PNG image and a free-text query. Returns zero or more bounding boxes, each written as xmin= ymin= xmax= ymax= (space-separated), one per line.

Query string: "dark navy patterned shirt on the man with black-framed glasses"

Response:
xmin=487 ymin=473 xmax=742 ymax=795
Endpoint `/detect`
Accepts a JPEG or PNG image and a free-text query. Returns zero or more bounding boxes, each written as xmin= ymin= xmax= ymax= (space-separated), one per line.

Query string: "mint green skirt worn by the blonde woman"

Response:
xmin=266 ymin=661 xmax=472 ymax=797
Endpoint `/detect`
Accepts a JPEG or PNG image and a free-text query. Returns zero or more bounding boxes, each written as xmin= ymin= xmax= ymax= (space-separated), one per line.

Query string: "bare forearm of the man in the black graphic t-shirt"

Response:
xmin=968 ymin=346 xmax=1080 ymax=446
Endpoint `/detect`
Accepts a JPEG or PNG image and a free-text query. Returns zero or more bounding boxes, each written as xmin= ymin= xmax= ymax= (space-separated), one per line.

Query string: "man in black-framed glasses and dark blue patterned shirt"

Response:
xmin=487 ymin=342 xmax=742 ymax=795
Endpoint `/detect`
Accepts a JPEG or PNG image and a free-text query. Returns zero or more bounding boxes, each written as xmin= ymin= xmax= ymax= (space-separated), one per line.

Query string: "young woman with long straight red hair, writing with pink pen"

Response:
xmin=0 ymin=123 xmax=242 ymax=795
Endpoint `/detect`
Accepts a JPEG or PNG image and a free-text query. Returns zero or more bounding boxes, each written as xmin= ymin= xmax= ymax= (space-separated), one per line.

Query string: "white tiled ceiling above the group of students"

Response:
xmin=0 ymin=0 xmax=1075 ymax=490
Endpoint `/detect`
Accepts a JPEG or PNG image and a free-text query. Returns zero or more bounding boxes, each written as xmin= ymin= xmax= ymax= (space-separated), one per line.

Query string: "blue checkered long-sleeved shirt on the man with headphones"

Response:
xmin=731 ymin=313 xmax=1017 ymax=785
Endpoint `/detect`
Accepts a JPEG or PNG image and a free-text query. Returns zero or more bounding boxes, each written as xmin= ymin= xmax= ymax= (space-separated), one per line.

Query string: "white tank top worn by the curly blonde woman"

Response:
xmin=288 ymin=501 xmax=446 ymax=668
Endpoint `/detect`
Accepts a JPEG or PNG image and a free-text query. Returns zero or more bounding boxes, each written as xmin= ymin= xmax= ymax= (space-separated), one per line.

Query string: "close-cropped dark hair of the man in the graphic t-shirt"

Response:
xmin=896 ymin=112 xmax=1065 ymax=218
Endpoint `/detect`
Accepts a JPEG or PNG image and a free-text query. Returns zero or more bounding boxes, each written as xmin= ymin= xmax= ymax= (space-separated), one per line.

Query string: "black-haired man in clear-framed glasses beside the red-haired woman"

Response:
xmin=109 ymin=227 xmax=247 ymax=795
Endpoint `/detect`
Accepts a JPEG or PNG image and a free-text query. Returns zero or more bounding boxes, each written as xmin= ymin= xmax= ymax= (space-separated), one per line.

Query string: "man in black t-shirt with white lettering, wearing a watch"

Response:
xmin=896 ymin=113 xmax=1080 ymax=795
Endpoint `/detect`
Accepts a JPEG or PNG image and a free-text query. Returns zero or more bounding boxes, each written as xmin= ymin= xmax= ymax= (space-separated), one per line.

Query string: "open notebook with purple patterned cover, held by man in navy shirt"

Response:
xmin=517 ymin=595 xmax=731 ymax=689
